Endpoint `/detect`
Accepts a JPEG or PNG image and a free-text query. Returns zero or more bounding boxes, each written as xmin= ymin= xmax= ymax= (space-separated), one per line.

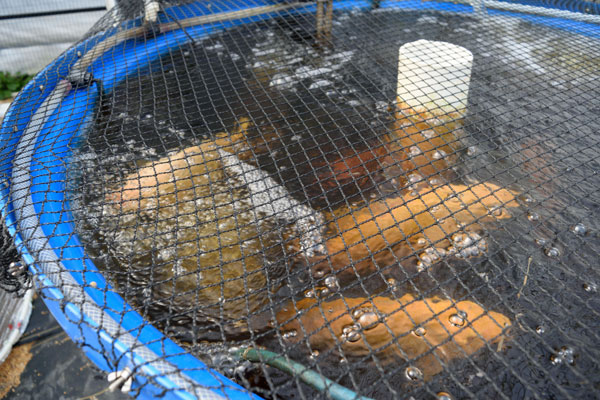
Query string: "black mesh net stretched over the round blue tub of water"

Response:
xmin=2 ymin=1 xmax=600 ymax=399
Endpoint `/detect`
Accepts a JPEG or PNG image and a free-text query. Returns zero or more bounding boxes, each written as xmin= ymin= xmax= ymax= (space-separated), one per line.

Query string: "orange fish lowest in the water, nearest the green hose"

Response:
xmin=277 ymin=294 xmax=511 ymax=379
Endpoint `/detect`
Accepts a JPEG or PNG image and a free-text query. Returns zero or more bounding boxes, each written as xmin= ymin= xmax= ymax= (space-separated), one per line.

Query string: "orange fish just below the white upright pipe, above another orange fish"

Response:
xmin=313 ymin=183 xmax=518 ymax=275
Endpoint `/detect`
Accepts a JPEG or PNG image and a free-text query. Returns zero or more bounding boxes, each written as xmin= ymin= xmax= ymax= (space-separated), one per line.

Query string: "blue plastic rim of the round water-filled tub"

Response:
xmin=0 ymin=0 xmax=600 ymax=399
